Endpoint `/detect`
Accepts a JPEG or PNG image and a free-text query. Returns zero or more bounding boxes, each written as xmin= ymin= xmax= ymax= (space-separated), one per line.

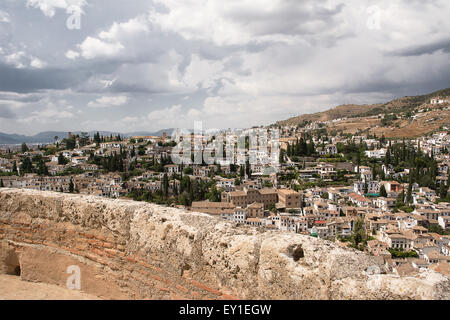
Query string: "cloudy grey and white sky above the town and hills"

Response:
xmin=0 ymin=0 xmax=450 ymax=135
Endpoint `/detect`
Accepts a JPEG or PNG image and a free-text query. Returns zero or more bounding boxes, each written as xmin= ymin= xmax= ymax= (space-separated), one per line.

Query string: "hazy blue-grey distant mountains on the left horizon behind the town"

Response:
xmin=0 ymin=129 xmax=173 ymax=145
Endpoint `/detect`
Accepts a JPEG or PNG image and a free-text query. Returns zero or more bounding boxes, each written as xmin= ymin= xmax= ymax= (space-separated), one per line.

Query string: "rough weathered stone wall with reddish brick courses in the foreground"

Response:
xmin=0 ymin=188 xmax=450 ymax=299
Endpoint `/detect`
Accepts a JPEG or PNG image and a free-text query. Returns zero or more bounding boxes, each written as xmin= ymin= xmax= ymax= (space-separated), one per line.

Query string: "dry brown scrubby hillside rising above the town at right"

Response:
xmin=276 ymin=88 xmax=450 ymax=137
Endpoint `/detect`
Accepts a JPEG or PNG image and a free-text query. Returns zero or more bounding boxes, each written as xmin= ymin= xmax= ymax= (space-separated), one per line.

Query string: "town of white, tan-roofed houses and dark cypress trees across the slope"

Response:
xmin=0 ymin=98 xmax=450 ymax=274
